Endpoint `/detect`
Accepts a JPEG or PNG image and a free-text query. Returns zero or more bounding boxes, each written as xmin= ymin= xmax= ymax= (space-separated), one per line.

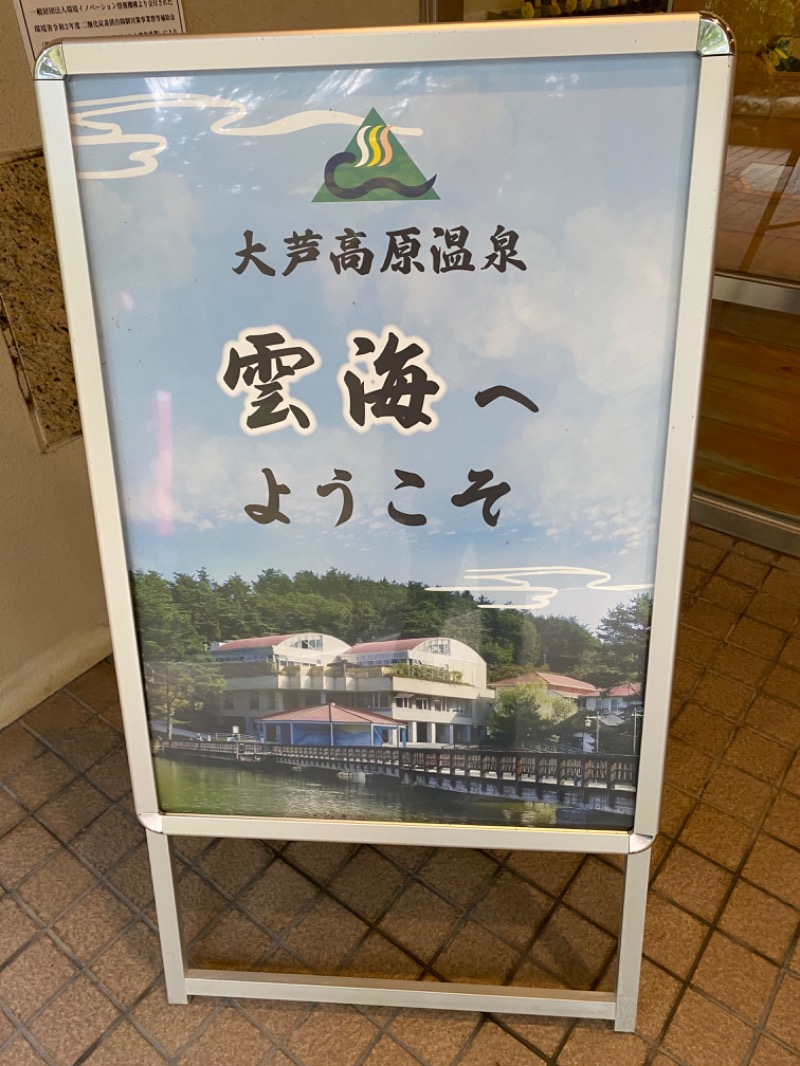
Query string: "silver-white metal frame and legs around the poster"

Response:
xmin=36 ymin=14 xmax=734 ymax=1030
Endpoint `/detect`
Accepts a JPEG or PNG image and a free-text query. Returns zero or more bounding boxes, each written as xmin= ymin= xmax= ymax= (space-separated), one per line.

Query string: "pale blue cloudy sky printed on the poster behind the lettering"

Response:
xmin=68 ymin=55 xmax=699 ymax=625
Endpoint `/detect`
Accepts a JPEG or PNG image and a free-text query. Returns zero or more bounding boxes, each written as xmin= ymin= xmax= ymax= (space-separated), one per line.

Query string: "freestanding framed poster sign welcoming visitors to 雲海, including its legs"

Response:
xmin=37 ymin=15 xmax=733 ymax=1028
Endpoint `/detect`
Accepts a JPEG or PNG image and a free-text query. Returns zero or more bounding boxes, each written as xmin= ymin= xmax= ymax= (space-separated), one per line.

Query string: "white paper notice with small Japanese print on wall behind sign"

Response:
xmin=14 ymin=0 xmax=186 ymax=68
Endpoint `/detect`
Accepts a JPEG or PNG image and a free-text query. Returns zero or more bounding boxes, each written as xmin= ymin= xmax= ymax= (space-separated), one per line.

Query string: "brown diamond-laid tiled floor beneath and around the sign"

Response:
xmin=0 ymin=529 xmax=800 ymax=1066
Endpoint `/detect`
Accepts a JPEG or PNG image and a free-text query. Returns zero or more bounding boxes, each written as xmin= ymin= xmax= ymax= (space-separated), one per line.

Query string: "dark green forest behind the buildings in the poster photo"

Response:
xmin=132 ymin=569 xmax=652 ymax=686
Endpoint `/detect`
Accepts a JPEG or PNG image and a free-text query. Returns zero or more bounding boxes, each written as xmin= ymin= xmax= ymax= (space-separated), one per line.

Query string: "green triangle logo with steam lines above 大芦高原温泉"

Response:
xmin=311 ymin=108 xmax=438 ymax=204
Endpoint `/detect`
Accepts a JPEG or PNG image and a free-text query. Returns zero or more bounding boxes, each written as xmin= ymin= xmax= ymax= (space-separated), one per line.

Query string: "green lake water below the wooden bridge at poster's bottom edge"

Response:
xmin=154 ymin=758 xmax=556 ymax=827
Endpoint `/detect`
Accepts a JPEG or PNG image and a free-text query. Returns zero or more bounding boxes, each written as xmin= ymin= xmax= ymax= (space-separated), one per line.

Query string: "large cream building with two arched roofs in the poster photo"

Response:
xmin=211 ymin=632 xmax=493 ymax=747
